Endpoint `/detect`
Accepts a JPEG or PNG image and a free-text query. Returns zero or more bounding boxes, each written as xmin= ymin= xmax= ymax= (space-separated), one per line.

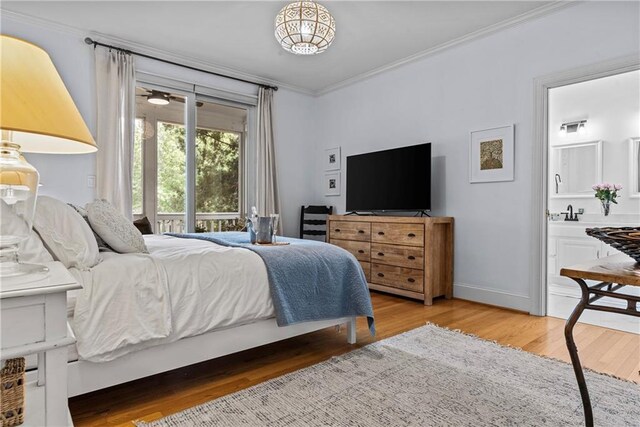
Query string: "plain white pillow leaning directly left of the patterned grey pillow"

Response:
xmin=33 ymin=196 xmax=100 ymax=270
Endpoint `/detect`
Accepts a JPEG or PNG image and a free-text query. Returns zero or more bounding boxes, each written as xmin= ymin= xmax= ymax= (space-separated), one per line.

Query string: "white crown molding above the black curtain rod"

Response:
xmin=1 ymin=9 xmax=316 ymax=96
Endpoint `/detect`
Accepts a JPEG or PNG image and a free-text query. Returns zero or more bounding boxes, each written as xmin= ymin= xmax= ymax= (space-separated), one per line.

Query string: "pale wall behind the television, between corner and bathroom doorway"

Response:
xmin=316 ymin=2 xmax=640 ymax=310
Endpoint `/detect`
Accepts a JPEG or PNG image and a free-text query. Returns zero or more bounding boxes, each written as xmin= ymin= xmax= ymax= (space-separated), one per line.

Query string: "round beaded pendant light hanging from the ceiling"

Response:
xmin=275 ymin=1 xmax=336 ymax=55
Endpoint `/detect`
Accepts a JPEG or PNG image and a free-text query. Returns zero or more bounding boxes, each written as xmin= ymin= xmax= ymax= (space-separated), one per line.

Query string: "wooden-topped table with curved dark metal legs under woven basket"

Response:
xmin=560 ymin=254 xmax=640 ymax=427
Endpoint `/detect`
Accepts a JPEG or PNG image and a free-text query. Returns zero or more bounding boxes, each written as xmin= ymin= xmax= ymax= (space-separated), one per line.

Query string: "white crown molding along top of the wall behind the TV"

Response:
xmin=314 ymin=0 xmax=583 ymax=96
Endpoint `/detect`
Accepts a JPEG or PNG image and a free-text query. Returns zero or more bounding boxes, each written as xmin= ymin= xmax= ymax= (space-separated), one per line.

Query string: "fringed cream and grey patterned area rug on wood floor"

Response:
xmin=137 ymin=325 xmax=640 ymax=427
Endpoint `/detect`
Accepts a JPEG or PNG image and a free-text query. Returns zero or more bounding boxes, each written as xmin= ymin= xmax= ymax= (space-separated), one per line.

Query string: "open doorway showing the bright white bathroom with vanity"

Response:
xmin=546 ymin=70 xmax=640 ymax=333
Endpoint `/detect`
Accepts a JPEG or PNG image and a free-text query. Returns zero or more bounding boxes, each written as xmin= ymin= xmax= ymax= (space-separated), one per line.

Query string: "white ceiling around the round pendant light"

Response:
xmin=0 ymin=1 xmax=558 ymax=93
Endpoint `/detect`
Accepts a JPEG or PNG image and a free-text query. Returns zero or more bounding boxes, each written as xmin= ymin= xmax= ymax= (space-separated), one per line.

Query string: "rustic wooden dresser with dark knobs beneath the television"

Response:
xmin=327 ymin=215 xmax=453 ymax=305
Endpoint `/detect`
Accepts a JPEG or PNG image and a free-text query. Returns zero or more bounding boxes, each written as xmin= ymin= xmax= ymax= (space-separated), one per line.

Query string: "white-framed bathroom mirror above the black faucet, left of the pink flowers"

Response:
xmin=549 ymin=141 xmax=602 ymax=198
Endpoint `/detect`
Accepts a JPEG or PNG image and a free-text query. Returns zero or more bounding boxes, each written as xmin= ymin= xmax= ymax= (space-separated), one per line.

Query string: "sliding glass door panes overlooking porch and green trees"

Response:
xmin=132 ymin=87 xmax=247 ymax=232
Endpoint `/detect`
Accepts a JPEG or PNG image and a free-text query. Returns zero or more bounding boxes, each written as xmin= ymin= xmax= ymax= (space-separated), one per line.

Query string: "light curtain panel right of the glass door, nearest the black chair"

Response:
xmin=256 ymin=87 xmax=283 ymax=230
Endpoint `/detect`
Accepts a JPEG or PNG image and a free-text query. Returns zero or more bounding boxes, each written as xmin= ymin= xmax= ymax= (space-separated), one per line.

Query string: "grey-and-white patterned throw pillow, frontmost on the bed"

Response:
xmin=87 ymin=200 xmax=149 ymax=254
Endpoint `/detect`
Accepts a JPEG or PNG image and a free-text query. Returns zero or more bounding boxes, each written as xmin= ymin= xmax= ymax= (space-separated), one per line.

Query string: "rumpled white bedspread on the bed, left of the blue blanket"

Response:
xmin=71 ymin=235 xmax=274 ymax=362
